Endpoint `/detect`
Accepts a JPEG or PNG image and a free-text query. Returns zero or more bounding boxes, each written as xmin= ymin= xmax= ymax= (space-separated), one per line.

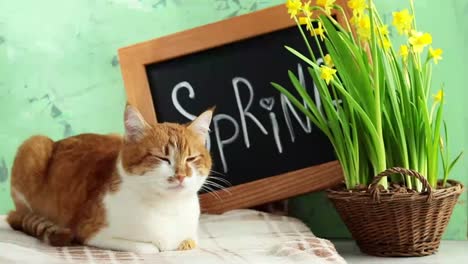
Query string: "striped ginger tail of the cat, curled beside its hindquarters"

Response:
xmin=7 ymin=211 xmax=73 ymax=247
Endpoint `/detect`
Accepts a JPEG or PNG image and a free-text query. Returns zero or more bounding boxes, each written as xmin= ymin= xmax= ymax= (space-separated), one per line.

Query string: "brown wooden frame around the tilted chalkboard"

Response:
xmin=118 ymin=0 xmax=347 ymax=213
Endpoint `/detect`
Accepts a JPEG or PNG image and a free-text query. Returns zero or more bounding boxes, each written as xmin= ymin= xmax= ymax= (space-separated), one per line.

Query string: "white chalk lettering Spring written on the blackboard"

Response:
xmin=171 ymin=69 xmax=330 ymax=173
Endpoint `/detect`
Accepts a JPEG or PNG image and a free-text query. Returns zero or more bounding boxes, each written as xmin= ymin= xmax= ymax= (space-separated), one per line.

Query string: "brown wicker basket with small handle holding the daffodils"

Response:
xmin=327 ymin=168 xmax=463 ymax=257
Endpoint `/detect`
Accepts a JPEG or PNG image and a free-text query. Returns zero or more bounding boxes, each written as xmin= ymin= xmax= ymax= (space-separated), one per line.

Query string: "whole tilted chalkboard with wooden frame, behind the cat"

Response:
xmin=119 ymin=3 xmax=345 ymax=213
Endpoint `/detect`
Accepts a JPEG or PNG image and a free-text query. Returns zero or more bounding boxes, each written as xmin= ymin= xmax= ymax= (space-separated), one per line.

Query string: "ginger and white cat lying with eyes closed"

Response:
xmin=8 ymin=105 xmax=212 ymax=253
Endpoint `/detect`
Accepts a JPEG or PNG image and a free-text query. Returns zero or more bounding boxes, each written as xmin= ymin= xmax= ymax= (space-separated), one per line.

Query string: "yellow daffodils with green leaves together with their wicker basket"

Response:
xmin=272 ymin=0 xmax=463 ymax=256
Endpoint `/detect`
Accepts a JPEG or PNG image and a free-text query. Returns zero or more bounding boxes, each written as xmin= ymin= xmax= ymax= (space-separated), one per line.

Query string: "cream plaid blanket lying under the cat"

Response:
xmin=0 ymin=210 xmax=346 ymax=264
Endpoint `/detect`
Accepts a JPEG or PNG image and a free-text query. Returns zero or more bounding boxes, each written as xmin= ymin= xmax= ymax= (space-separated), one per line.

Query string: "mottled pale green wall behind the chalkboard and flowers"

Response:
xmin=0 ymin=0 xmax=468 ymax=239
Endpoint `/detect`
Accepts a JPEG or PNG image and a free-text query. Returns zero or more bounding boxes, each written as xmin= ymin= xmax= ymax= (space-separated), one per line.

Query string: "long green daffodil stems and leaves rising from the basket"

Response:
xmin=278 ymin=0 xmax=462 ymax=190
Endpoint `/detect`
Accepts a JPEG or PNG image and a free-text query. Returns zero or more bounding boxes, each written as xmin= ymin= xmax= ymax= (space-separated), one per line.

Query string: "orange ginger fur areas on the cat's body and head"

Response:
xmin=7 ymin=106 xmax=211 ymax=249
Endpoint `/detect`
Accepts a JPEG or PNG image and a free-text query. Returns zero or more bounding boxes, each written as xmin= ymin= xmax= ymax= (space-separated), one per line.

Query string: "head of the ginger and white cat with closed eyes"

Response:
xmin=120 ymin=105 xmax=213 ymax=195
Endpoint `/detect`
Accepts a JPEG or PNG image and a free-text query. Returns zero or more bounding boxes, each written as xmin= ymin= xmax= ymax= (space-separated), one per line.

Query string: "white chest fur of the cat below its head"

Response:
xmin=88 ymin=182 xmax=200 ymax=251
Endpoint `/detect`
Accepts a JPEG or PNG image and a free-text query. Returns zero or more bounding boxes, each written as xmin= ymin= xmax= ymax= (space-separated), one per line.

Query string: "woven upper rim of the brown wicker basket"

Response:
xmin=326 ymin=179 xmax=464 ymax=201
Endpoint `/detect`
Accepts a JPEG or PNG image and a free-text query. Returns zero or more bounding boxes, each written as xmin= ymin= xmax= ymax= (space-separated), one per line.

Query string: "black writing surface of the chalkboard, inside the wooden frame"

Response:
xmin=146 ymin=26 xmax=335 ymax=190
